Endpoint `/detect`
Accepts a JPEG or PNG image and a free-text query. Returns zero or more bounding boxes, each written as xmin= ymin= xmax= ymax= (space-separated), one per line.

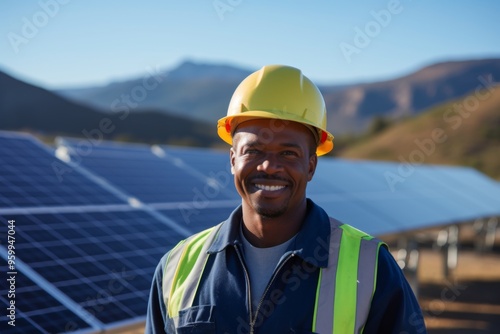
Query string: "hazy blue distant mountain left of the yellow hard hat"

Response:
xmin=55 ymin=61 xmax=252 ymax=123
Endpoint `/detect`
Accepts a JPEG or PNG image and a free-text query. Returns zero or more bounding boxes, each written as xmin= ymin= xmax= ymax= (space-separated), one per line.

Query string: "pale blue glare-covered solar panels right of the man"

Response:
xmin=308 ymin=158 xmax=500 ymax=235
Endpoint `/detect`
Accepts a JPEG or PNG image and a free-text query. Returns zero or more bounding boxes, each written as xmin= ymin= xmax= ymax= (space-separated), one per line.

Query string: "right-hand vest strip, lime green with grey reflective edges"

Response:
xmin=312 ymin=219 xmax=384 ymax=333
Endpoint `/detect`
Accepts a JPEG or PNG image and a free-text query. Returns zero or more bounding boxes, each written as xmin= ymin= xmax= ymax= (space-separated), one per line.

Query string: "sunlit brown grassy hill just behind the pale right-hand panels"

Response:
xmin=337 ymin=86 xmax=500 ymax=179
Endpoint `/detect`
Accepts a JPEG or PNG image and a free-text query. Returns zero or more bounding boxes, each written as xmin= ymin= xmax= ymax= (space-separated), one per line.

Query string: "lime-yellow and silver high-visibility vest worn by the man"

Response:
xmin=162 ymin=219 xmax=385 ymax=334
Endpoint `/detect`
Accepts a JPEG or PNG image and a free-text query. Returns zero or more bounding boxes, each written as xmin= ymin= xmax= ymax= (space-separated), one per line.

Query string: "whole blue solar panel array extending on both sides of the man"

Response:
xmin=0 ymin=132 xmax=500 ymax=333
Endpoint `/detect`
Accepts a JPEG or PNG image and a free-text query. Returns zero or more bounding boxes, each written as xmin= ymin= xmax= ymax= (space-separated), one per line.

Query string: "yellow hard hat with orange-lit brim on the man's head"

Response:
xmin=217 ymin=65 xmax=333 ymax=155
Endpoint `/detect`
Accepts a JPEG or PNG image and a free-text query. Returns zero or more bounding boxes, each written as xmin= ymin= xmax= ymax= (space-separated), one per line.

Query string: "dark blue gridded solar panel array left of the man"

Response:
xmin=0 ymin=132 xmax=234 ymax=333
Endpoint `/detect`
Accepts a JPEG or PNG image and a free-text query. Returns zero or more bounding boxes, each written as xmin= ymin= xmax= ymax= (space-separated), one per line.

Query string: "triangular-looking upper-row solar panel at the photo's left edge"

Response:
xmin=0 ymin=132 xmax=123 ymax=208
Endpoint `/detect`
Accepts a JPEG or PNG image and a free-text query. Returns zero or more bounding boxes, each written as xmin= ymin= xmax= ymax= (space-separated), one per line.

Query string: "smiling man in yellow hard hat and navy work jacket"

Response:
xmin=146 ymin=66 xmax=426 ymax=334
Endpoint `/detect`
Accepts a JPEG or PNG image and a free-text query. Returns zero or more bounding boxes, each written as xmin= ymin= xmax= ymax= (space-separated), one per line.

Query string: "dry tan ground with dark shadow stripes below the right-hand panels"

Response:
xmin=410 ymin=231 xmax=500 ymax=334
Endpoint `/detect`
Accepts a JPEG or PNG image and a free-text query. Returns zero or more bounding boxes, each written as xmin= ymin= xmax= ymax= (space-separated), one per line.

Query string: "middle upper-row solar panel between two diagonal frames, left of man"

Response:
xmin=59 ymin=139 xmax=238 ymax=203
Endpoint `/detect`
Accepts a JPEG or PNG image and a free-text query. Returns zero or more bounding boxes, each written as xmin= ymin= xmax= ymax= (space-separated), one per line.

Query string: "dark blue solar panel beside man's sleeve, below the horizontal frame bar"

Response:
xmin=0 ymin=208 xmax=184 ymax=324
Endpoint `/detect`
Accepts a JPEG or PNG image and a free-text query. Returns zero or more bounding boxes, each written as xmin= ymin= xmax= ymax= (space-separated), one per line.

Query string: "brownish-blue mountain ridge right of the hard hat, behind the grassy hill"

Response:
xmin=322 ymin=59 xmax=500 ymax=134
